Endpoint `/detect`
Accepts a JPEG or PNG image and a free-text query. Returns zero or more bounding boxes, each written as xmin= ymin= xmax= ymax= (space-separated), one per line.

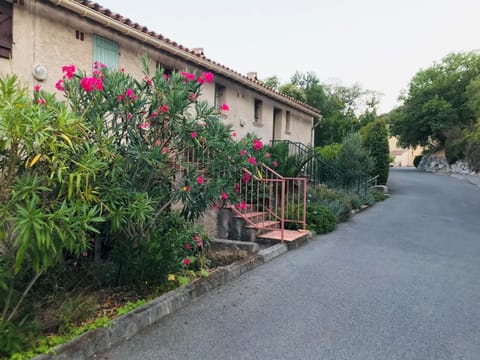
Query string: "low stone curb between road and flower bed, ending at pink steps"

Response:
xmin=34 ymin=244 xmax=288 ymax=360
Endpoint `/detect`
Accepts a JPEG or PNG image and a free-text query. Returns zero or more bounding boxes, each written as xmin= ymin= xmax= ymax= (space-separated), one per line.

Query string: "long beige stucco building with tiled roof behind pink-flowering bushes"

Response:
xmin=0 ymin=0 xmax=320 ymax=145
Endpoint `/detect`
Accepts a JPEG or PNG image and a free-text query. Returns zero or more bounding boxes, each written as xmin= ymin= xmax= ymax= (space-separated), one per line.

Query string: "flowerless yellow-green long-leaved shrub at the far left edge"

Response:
xmin=0 ymin=76 xmax=106 ymax=347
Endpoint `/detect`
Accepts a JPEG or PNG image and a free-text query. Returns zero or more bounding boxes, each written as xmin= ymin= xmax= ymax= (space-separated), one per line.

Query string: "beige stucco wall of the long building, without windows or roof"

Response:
xmin=0 ymin=0 xmax=313 ymax=144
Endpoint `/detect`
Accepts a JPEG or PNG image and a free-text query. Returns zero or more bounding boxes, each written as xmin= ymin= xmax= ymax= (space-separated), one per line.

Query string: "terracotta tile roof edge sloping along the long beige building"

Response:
xmin=66 ymin=0 xmax=320 ymax=114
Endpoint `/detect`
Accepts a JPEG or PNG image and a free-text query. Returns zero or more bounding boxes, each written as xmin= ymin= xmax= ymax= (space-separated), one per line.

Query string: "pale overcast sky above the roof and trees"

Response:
xmin=97 ymin=0 xmax=480 ymax=112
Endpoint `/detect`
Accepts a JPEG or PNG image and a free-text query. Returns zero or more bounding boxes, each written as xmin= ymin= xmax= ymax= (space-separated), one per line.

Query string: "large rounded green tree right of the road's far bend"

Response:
xmin=389 ymin=52 xmax=480 ymax=147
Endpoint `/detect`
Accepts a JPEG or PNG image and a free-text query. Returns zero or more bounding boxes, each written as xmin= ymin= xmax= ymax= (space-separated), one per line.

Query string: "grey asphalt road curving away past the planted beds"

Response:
xmin=100 ymin=169 xmax=480 ymax=360
